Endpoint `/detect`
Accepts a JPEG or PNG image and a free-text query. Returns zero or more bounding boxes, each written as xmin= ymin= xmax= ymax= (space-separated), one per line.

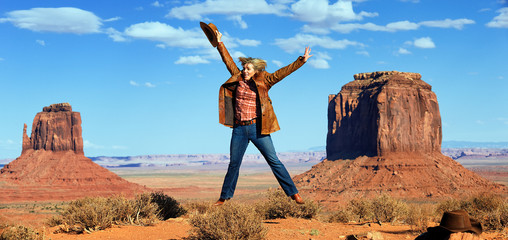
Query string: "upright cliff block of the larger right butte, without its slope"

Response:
xmin=326 ymin=71 xmax=442 ymax=160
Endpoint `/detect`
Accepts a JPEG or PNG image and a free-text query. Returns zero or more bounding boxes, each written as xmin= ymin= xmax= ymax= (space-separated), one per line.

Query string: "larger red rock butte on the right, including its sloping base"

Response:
xmin=294 ymin=71 xmax=507 ymax=203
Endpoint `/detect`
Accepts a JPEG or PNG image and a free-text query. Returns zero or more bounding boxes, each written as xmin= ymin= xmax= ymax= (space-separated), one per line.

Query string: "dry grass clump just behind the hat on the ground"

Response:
xmin=437 ymin=194 xmax=508 ymax=230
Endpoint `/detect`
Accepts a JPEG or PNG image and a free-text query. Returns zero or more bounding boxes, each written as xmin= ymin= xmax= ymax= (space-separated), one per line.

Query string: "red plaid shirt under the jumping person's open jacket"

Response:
xmin=235 ymin=80 xmax=258 ymax=121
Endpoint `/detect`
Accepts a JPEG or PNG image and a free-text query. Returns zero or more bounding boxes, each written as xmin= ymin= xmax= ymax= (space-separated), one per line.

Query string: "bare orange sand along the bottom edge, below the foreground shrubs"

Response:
xmin=46 ymin=218 xmax=506 ymax=240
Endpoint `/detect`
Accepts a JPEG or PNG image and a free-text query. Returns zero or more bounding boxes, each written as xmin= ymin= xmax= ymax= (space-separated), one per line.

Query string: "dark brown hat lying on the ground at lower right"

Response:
xmin=428 ymin=210 xmax=482 ymax=235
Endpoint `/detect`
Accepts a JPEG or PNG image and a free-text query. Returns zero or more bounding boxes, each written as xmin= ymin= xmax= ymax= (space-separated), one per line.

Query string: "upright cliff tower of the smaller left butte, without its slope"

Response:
xmin=21 ymin=103 xmax=83 ymax=154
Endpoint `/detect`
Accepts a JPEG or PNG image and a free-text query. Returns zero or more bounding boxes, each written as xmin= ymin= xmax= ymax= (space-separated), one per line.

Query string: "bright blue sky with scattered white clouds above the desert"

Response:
xmin=0 ymin=0 xmax=508 ymax=159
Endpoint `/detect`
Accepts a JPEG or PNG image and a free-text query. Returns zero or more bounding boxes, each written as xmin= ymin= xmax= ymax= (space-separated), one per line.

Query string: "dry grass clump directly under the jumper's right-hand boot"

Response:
xmin=256 ymin=189 xmax=320 ymax=219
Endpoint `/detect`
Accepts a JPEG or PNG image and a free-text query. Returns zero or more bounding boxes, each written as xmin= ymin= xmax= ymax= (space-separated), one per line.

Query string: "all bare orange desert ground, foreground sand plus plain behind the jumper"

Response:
xmin=0 ymin=165 xmax=508 ymax=240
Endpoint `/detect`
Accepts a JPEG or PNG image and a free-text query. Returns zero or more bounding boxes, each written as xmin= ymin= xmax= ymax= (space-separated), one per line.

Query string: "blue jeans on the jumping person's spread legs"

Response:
xmin=220 ymin=123 xmax=298 ymax=199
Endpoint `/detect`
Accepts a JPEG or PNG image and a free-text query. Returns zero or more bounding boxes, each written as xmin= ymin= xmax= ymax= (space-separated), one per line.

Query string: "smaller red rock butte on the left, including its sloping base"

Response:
xmin=0 ymin=103 xmax=148 ymax=202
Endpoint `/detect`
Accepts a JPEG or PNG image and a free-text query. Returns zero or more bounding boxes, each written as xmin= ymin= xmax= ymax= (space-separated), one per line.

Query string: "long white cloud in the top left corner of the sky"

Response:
xmin=1 ymin=7 xmax=102 ymax=34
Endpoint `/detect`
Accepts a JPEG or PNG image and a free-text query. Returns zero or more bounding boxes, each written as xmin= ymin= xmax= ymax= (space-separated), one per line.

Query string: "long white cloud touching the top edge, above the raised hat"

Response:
xmin=166 ymin=0 xmax=287 ymax=20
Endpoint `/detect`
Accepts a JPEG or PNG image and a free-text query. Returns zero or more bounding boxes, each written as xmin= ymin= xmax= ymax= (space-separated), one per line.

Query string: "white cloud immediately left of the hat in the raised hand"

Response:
xmin=124 ymin=22 xmax=211 ymax=48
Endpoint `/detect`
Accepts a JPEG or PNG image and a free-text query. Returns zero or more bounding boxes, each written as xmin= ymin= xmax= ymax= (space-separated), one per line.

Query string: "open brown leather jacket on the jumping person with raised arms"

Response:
xmin=217 ymin=43 xmax=305 ymax=135
